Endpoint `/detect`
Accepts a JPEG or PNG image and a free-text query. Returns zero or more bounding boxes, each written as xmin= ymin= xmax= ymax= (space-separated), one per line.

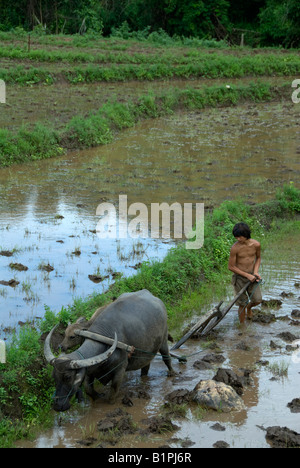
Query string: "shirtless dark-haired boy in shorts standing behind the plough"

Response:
xmin=228 ymin=223 xmax=262 ymax=323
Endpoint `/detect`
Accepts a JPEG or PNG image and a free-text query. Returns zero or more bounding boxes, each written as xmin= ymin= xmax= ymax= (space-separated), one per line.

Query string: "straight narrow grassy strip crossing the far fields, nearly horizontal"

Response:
xmin=0 ymin=54 xmax=300 ymax=84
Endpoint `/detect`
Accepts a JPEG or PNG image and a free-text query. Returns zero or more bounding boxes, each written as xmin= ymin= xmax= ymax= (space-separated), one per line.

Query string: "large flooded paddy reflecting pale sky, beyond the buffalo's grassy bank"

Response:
xmin=0 ymin=103 xmax=300 ymax=332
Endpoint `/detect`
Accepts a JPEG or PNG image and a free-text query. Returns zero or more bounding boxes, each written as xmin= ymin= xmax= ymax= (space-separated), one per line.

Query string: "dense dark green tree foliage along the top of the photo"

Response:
xmin=0 ymin=0 xmax=300 ymax=47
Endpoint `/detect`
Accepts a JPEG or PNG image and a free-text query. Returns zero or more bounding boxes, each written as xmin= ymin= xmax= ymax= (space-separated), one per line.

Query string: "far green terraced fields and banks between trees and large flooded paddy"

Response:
xmin=0 ymin=27 xmax=300 ymax=167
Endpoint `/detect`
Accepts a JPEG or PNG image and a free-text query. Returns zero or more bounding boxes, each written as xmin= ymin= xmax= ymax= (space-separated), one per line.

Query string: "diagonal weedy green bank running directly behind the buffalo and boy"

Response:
xmin=0 ymin=184 xmax=300 ymax=447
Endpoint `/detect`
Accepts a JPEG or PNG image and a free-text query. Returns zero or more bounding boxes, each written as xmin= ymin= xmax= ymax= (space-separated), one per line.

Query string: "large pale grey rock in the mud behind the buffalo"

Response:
xmin=193 ymin=380 xmax=245 ymax=413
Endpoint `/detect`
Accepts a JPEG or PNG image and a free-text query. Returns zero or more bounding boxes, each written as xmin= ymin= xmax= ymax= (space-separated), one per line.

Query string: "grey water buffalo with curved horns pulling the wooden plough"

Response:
xmin=44 ymin=289 xmax=174 ymax=411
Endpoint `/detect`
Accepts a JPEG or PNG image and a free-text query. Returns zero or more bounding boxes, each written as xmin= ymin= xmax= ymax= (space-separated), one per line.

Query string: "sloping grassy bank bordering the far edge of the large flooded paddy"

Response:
xmin=0 ymin=82 xmax=291 ymax=167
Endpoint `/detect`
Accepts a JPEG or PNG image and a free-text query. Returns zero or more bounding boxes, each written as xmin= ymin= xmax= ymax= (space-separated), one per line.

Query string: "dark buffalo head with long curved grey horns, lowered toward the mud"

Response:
xmin=44 ymin=326 xmax=118 ymax=411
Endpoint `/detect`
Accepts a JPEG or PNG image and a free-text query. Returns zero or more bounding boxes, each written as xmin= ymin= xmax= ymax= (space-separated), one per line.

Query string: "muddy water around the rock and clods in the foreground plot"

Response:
xmin=18 ymin=261 xmax=300 ymax=449
